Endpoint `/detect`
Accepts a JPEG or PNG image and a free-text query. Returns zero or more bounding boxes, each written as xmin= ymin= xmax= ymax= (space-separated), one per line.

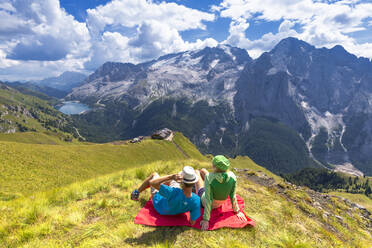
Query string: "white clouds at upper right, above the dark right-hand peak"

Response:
xmin=217 ymin=0 xmax=372 ymax=57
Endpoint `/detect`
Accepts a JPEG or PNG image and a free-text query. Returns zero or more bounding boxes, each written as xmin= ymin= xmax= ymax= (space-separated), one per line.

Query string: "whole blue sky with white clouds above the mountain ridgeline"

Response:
xmin=0 ymin=0 xmax=372 ymax=81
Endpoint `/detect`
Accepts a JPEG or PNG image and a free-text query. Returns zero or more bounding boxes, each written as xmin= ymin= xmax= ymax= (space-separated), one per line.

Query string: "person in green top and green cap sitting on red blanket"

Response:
xmin=196 ymin=155 xmax=247 ymax=230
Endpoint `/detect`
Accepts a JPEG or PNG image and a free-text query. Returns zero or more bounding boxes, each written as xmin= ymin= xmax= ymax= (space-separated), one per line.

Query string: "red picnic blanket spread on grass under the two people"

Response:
xmin=134 ymin=195 xmax=256 ymax=230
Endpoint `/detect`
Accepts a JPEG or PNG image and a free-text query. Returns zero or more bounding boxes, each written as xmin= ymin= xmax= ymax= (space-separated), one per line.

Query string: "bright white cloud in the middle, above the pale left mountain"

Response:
xmin=86 ymin=0 xmax=217 ymax=69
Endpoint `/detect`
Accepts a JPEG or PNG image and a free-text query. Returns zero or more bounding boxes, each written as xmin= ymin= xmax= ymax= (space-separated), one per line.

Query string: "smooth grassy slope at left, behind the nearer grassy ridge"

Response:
xmin=0 ymin=134 xmax=198 ymax=194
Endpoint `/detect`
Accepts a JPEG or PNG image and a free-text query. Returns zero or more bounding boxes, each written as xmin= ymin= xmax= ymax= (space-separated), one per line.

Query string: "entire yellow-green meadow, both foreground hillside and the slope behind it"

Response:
xmin=0 ymin=133 xmax=372 ymax=248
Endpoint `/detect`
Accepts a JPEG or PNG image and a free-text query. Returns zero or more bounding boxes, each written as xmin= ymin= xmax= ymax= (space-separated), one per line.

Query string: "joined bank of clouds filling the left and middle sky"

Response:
xmin=0 ymin=0 xmax=217 ymax=79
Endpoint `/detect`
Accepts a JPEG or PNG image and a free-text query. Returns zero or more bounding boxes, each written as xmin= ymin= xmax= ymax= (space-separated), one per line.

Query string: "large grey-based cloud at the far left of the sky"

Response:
xmin=0 ymin=0 xmax=90 ymax=80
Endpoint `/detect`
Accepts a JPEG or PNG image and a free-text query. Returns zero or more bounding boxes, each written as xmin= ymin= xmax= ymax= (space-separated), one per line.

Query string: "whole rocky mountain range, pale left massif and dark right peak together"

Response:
xmin=69 ymin=38 xmax=372 ymax=173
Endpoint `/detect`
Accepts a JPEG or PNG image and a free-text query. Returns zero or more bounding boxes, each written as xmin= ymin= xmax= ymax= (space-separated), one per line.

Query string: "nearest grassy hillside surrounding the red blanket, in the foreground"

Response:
xmin=0 ymin=160 xmax=372 ymax=248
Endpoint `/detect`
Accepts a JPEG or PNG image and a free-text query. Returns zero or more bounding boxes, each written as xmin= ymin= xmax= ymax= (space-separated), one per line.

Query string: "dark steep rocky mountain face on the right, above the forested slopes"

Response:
xmin=235 ymin=38 xmax=372 ymax=174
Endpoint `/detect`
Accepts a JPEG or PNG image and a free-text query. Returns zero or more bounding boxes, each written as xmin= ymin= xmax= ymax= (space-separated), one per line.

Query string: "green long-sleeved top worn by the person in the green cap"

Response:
xmin=202 ymin=171 xmax=239 ymax=221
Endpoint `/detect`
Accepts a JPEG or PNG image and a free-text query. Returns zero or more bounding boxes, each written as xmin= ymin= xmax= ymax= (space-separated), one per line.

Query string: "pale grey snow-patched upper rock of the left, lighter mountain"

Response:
xmin=69 ymin=45 xmax=250 ymax=110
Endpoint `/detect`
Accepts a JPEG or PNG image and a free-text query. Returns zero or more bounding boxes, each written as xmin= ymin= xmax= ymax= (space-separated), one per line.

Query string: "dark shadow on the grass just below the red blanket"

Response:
xmin=125 ymin=226 xmax=189 ymax=246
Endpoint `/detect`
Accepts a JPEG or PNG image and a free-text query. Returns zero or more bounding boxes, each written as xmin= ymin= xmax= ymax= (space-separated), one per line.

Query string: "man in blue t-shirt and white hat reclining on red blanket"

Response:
xmin=131 ymin=166 xmax=200 ymax=225
